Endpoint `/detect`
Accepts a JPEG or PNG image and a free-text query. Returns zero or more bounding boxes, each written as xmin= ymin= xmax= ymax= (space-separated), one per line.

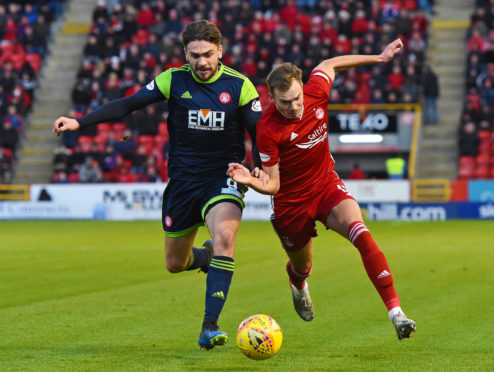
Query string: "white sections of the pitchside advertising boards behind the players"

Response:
xmin=0 ymin=181 xmax=410 ymax=220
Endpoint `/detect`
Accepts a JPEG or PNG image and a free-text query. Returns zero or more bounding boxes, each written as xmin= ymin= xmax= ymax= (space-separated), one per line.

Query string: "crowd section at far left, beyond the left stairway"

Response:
xmin=0 ymin=0 xmax=64 ymax=183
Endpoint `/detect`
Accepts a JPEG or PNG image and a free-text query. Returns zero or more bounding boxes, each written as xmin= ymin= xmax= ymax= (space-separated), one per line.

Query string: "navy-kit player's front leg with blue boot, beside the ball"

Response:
xmin=199 ymin=200 xmax=242 ymax=349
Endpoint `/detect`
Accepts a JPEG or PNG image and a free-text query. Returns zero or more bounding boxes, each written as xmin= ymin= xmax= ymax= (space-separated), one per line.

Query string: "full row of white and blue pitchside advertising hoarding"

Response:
xmin=0 ymin=180 xmax=494 ymax=221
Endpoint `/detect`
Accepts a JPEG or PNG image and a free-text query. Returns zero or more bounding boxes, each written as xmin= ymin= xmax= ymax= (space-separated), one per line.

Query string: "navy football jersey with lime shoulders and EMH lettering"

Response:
xmin=152 ymin=64 xmax=261 ymax=180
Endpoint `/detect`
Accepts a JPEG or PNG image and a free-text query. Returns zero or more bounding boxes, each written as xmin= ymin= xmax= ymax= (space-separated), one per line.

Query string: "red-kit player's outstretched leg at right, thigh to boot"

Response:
xmin=326 ymin=198 xmax=415 ymax=340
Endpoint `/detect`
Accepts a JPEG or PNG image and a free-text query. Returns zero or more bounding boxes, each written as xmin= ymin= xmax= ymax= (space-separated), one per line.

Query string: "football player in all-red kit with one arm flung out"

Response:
xmin=227 ymin=39 xmax=415 ymax=340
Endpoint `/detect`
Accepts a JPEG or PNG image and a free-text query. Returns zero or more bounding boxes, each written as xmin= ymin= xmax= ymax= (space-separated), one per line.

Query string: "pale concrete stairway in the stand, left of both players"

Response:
xmin=14 ymin=0 xmax=96 ymax=184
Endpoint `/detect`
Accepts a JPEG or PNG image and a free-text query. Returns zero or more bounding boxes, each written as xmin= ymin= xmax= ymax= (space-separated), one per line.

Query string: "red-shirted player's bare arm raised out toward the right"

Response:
xmin=315 ymin=39 xmax=403 ymax=80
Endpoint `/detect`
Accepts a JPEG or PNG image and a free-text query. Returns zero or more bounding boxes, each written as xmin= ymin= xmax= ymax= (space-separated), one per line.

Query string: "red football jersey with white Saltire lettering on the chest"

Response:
xmin=257 ymin=70 xmax=334 ymax=206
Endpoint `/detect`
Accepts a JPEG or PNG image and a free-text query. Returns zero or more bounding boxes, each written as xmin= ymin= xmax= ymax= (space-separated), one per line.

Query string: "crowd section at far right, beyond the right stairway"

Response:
xmin=458 ymin=0 xmax=494 ymax=178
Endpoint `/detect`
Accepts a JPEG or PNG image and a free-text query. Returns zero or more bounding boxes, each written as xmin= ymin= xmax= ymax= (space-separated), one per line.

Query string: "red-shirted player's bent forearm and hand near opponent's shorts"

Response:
xmin=226 ymin=163 xmax=280 ymax=195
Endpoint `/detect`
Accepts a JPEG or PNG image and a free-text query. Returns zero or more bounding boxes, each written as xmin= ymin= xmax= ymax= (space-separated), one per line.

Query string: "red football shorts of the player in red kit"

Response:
xmin=271 ymin=172 xmax=355 ymax=252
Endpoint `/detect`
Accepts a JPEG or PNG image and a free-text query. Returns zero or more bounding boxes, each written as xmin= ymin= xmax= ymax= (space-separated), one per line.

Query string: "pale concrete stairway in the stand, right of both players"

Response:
xmin=416 ymin=0 xmax=474 ymax=180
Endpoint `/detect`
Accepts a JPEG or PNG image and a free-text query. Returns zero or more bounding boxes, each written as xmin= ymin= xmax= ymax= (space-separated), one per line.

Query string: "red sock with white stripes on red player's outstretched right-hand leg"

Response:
xmin=348 ymin=221 xmax=400 ymax=310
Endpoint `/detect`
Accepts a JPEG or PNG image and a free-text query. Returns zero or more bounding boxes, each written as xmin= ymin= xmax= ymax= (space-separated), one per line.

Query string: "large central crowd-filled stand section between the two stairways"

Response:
xmin=48 ymin=0 xmax=434 ymax=182
